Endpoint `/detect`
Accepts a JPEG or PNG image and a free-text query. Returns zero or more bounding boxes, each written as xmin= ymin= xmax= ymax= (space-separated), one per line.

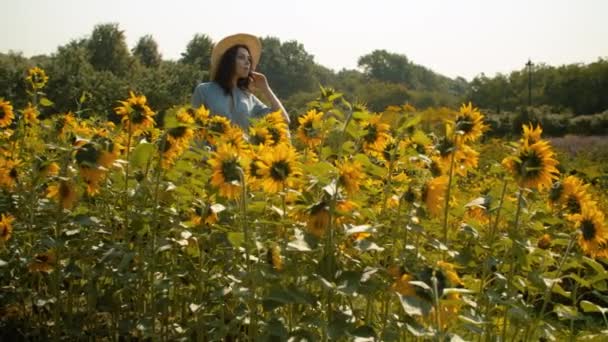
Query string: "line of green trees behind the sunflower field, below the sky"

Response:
xmin=0 ymin=23 xmax=608 ymax=120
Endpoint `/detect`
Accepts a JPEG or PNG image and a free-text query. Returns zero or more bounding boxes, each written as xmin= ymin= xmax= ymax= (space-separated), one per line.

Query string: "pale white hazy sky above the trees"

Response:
xmin=0 ymin=0 xmax=608 ymax=80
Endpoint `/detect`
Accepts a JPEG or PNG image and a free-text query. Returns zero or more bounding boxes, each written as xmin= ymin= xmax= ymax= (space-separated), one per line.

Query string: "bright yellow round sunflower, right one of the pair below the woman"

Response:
xmin=257 ymin=144 xmax=301 ymax=193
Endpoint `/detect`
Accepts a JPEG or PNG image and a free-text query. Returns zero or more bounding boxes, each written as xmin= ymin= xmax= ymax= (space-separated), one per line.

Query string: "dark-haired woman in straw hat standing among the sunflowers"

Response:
xmin=192 ymin=33 xmax=289 ymax=131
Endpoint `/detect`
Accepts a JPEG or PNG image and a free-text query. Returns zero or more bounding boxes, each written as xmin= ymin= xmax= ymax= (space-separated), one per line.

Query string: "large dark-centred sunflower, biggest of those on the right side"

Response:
xmin=502 ymin=140 xmax=559 ymax=190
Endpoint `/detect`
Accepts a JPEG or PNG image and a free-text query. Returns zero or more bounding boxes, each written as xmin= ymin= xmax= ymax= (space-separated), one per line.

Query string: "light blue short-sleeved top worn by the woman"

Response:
xmin=192 ymin=82 xmax=272 ymax=132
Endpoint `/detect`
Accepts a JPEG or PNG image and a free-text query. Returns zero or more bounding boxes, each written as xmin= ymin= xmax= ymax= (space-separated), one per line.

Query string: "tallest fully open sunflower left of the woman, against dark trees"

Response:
xmin=114 ymin=91 xmax=155 ymax=135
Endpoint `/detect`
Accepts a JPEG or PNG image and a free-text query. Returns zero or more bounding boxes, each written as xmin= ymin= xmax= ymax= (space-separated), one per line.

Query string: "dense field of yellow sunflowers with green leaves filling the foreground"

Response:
xmin=0 ymin=68 xmax=608 ymax=341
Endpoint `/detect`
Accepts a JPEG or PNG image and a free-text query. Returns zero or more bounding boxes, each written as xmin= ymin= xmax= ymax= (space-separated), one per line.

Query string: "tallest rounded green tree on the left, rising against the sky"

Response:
xmin=87 ymin=24 xmax=130 ymax=76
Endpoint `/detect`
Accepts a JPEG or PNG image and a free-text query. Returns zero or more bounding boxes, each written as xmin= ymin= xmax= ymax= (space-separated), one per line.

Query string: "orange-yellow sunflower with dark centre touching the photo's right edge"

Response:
xmin=572 ymin=206 xmax=608 ymax=258
